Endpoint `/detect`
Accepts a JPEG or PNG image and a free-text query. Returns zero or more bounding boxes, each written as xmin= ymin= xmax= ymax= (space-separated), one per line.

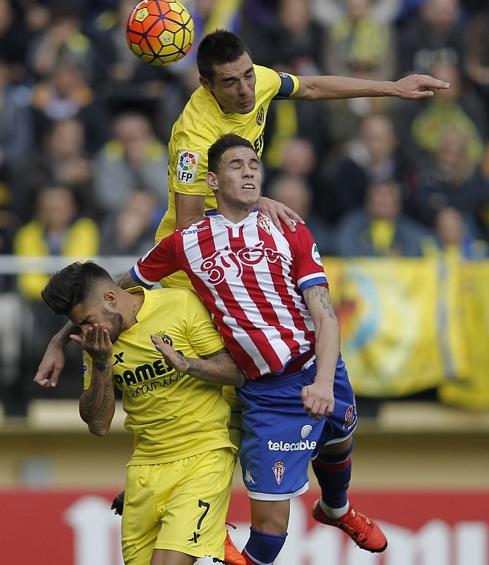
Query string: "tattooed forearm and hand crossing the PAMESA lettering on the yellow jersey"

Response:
xmin=151 ymin=335 xmax=245 ymax=386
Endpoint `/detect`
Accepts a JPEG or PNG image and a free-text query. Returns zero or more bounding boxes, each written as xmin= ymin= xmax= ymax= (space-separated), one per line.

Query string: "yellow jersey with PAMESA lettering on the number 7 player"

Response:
xmin=84 ymin=287 xmax=235 ymax=465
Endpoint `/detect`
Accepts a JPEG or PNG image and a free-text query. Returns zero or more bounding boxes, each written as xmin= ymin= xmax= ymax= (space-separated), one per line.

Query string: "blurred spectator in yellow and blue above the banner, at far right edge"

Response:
xmin=423 ymin=207 xmax=489 ymax=261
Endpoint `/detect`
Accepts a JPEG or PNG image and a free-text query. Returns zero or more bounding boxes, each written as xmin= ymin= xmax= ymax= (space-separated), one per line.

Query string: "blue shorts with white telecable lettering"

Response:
xmin=238 ymin=356 xmax=357 ymax=500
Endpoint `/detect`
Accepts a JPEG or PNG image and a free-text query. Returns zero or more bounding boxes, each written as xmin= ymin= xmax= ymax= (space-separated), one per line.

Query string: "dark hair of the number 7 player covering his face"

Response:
xmin=41 ymin=261 xmax=113 ymax=315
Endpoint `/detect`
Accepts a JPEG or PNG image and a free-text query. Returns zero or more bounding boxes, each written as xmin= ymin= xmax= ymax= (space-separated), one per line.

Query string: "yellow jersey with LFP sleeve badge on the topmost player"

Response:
xmin=156 ymin=65 xmax=299 ymax=288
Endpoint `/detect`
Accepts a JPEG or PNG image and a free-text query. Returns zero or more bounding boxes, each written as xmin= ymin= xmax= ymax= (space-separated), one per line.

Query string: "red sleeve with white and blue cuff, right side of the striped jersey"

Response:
xmin=285 ymin=224 xmax=329 ymax=292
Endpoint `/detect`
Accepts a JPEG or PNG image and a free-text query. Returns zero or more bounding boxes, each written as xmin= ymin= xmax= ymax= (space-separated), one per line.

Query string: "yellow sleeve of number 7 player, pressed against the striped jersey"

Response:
xmin=187 ymin=292 xmax=224 ymax=357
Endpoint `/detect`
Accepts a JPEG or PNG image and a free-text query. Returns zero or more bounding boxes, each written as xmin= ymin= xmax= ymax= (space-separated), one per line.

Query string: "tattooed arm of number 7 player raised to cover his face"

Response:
xmin=71 ymin=324 xmax=115 ymax=436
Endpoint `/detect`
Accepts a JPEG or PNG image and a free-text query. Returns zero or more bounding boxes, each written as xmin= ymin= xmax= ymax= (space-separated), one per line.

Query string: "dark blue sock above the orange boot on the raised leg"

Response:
xmin=312 ymin=445 xmax=353 ymax=508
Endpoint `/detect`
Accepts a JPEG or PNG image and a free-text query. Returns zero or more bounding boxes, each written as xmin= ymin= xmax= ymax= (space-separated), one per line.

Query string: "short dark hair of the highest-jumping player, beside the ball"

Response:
xmin=197 ymin=29 xmax=251 ymax=82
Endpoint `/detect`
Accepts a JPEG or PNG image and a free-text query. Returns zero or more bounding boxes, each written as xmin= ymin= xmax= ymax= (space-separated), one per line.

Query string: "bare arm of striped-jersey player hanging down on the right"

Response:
xmin=302 ymin=286 xmax=340 ymax=418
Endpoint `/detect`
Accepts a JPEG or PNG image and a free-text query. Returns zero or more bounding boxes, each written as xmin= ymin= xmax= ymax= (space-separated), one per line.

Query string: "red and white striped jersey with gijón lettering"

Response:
xmin=131 ymin=212 xmax=327 ymax=379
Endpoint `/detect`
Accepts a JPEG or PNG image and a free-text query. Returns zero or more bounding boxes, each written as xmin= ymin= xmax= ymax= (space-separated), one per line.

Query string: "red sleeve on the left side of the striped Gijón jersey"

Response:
xmin=129 ymin=234 xmax=180 ymax=288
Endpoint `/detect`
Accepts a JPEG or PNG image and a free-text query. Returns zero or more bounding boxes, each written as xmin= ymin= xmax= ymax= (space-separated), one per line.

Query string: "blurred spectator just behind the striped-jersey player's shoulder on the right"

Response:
xmin=269 ymin=175 xmax=334 ymax=255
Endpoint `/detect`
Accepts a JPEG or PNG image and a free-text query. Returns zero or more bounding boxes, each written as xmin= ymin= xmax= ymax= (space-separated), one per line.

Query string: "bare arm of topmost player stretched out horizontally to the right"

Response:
xmin=293 ymin=75 xmax=450 ymax=100
